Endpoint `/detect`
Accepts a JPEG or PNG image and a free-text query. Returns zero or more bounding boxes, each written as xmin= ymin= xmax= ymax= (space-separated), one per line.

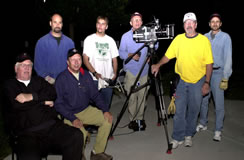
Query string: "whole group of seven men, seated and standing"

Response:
xmin=5 ymin=12 xmax=232 ymax=160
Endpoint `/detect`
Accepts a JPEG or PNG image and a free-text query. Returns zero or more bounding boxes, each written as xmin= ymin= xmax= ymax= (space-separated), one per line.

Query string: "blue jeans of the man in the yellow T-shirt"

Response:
xmin=172 ymin=76 xmax=205 ymax=141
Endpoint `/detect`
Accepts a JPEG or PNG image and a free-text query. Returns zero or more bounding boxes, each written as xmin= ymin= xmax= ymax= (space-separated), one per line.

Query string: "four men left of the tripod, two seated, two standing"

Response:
xmin=4 ymin=14 xmax=115 ymax=160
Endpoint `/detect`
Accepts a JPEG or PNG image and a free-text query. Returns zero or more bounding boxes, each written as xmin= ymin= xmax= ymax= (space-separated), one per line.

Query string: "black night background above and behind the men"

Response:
xmin=1 ymin=0 xmax=244 ymax=98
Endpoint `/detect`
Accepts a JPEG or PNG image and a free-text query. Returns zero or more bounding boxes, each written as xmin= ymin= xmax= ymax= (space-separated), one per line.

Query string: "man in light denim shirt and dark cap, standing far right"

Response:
xmin=196 ymin=13 xmax=232 ymax=141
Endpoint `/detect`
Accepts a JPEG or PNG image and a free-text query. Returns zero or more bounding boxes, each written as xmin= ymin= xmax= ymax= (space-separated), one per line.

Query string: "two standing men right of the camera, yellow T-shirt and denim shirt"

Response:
xmin=151 ymin=12 xmax=232 ymax=148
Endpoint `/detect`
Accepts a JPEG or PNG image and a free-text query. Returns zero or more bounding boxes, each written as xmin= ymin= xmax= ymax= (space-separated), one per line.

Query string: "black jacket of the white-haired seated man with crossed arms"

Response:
xmin=4 ymin=76 xmax=57 ymax=134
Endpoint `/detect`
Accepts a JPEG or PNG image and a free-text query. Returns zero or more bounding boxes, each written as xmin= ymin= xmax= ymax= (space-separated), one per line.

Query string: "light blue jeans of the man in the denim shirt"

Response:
xmin=199 ymin=70 xmax=225 ymax=131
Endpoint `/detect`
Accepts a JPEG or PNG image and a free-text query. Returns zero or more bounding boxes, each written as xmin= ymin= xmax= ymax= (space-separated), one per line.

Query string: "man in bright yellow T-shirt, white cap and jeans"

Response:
xmin=151 ymin=12 xmax=213 ymax=148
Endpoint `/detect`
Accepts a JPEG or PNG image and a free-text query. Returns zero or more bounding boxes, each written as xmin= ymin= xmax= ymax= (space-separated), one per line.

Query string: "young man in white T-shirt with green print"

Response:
xmin=83 ymin=16 xmax=119 ymax=111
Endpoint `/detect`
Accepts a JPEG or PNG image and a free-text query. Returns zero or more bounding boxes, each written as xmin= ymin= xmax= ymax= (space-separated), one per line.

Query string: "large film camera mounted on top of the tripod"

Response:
xmin=133 ymin=17 xmax=174 ymax=43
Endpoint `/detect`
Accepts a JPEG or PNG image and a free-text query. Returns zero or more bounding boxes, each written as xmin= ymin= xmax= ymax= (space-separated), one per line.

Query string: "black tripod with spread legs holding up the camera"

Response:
xmin=110 ymin=42 xmax=172 ymax=153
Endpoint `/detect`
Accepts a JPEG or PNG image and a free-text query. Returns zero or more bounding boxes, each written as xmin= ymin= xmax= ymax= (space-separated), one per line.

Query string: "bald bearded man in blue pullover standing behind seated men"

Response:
xmin=34 ymin=13 xmax=74 ymax=84
